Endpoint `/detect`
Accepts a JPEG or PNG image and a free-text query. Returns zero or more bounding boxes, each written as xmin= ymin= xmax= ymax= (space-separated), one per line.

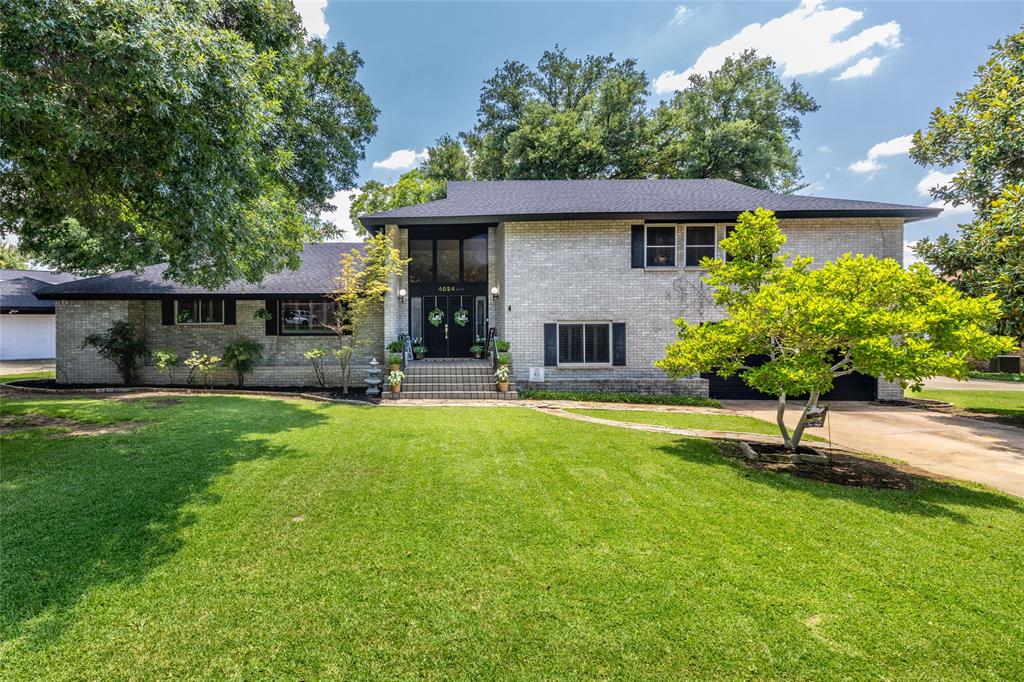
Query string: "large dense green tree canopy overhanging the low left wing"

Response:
xmin=0 ymin=0 xmax=377 ymax=287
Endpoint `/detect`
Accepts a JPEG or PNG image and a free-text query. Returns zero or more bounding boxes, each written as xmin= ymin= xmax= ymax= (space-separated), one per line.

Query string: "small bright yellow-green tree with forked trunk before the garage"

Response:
xmin=655 ymin=209 xmax=1012 ymax=451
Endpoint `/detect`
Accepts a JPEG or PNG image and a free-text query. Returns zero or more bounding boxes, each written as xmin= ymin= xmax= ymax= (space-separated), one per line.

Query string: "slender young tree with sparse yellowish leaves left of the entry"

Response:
xmin=326 ymin=231 xmax=409 ymax=393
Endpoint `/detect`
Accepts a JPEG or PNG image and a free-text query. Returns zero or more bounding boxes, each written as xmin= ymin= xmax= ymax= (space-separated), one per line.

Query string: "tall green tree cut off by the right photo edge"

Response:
xmin=910 ymin=32 xmax=1024 ymax=343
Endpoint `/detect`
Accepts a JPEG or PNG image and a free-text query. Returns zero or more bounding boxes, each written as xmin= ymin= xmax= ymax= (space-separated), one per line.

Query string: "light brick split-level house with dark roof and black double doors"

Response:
xmin=40 ymin=180 xmax=939 ymax=399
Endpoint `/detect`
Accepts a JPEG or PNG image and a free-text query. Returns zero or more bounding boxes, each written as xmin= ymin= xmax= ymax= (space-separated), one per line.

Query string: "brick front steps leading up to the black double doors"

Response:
xmin=387 ymin=359 xmax=518 ymax=400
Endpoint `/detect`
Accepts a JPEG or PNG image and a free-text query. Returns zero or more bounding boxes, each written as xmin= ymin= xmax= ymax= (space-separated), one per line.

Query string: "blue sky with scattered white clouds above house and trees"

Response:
xmin=296 ymin=0 xmax=1024 ymax=251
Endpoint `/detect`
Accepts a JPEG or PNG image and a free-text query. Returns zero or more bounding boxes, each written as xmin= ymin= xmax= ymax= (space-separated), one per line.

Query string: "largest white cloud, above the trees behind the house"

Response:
xmin=654 ymin=0 xmax=900 ymax=93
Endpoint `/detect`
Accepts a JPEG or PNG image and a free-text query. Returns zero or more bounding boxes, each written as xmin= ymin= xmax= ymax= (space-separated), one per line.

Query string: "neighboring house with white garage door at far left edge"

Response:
xmin=0 ymin=268 xmax=75 ymax=360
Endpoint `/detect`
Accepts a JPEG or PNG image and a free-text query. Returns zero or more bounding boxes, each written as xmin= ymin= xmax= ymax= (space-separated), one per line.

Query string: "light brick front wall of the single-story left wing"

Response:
xmin=56 ymin=300 xmax=384 ymax=386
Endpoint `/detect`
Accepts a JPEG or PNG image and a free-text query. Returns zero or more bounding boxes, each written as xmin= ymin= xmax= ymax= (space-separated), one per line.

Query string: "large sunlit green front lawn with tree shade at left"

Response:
xmin=0 ymin=396 xmax=1024 ymax=680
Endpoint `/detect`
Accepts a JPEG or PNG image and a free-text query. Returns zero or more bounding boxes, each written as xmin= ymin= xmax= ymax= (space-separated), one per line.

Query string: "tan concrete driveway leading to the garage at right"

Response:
xmin=722 ymin=393 xmax=1024 ymax=498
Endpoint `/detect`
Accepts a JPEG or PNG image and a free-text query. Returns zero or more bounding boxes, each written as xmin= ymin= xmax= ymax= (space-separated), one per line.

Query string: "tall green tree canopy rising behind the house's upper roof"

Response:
xmin=351 ymin=46 xmax=818 ymax=231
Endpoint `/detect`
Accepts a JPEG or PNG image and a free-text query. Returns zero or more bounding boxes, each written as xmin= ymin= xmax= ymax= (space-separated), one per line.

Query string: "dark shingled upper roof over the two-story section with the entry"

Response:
xmin=359 ymin=179 xmax=941 ymax=227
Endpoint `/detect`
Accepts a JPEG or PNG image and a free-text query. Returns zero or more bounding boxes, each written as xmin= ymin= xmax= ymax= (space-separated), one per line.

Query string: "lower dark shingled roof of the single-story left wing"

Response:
xmin=36 ymin=242 xmax=362 ymax=299
